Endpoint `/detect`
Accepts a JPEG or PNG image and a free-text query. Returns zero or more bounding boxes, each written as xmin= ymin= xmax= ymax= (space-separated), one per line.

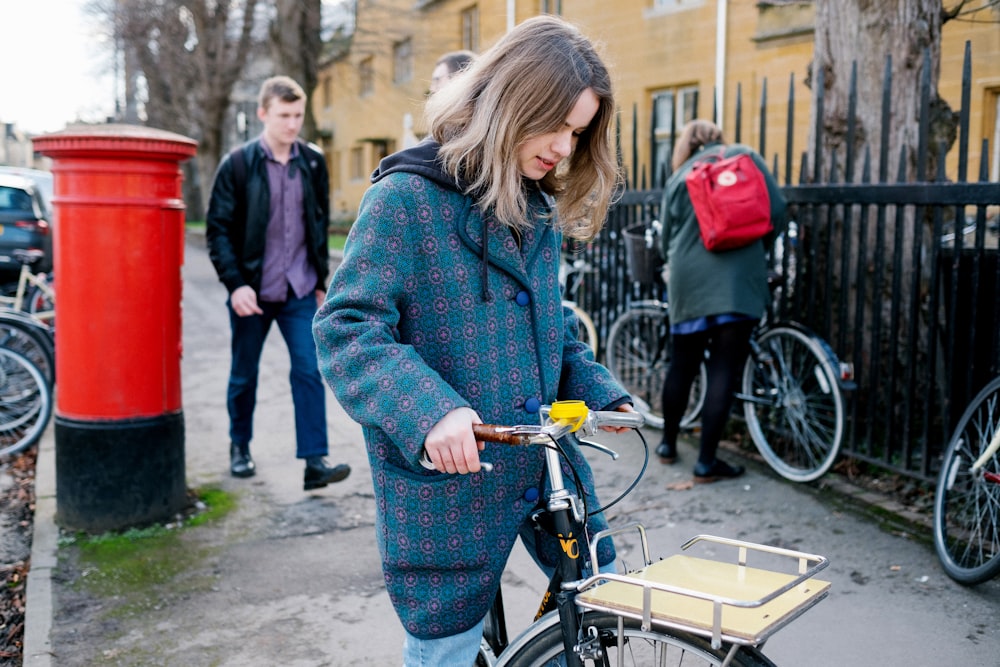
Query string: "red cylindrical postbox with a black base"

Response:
xmin=34 ymin=125 xmax=197 ymax=532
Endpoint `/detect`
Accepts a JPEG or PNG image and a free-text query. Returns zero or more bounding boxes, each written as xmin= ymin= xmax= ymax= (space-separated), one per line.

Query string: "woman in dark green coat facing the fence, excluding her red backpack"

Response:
xmin=656 ymin=120 xmax=785 ymax=483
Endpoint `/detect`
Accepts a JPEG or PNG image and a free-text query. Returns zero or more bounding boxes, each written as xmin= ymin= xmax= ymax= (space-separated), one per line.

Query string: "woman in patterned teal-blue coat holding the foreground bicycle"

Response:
xmin=313 ymin=16 xmax=631 ymax=666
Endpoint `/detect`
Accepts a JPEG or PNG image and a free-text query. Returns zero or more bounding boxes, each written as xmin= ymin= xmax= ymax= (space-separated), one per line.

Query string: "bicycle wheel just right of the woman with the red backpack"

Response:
xmin=738 ymin=325 xmax=845 ymax=482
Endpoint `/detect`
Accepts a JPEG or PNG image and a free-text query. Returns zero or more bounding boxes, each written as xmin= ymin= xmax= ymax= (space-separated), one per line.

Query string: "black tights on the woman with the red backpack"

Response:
xmin=663 ymin=320 xmax=757 ymax=465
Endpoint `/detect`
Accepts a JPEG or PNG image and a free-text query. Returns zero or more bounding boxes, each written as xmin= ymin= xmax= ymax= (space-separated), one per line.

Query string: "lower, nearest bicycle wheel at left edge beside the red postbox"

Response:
xmin=0 ymin=348 xmax=52 ymax=457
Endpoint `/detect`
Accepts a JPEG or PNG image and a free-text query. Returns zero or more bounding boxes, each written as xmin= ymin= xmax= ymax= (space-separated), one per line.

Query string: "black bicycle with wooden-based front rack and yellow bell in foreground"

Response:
xmin=448 ymin=401 xmax=830 ymax=667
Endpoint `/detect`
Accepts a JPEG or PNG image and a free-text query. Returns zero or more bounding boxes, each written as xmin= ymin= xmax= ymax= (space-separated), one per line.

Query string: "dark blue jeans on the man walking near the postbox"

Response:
xmin=226 ymin=292 xmax=328 ymax=459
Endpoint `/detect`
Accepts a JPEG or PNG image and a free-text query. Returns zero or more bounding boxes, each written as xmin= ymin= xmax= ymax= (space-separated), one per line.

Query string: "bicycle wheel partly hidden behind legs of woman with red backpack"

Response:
xmin=605 ymin=302 xmax=708 ymax=429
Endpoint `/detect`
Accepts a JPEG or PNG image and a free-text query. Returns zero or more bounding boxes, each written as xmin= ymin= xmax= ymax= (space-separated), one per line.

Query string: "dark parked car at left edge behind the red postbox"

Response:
xmin=0 ymin=172 xmax=52 ymax=282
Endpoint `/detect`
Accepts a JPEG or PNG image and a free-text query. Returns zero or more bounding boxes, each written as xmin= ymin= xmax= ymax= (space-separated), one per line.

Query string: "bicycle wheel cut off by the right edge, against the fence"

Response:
xmin=934 ymin=377 xmax=1000 ymax=586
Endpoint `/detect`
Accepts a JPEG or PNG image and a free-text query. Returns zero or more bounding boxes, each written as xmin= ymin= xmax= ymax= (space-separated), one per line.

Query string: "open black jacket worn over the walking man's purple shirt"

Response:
xmin=205 ymin=138 xmax=330 ymax=293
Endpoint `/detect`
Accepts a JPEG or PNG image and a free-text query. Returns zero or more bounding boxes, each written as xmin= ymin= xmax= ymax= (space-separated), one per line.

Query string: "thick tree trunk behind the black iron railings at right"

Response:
xmin=800 ymin=0 xmax=957 ymax=448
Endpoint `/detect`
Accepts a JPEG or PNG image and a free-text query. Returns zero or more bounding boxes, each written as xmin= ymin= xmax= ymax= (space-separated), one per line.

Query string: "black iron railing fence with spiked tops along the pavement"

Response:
xmin=580 ymin=41 xmax=1000 ymax=481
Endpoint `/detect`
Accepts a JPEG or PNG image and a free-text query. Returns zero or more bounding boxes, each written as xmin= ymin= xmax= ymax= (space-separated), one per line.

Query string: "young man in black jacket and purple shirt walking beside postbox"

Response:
xmin=206 ymin=76 xmax=350 ymax=491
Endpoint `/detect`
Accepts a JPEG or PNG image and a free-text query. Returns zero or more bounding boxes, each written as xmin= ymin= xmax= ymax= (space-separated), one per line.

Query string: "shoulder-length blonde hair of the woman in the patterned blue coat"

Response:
xmin=426 ymin=16 xmax=620 ymax=238
